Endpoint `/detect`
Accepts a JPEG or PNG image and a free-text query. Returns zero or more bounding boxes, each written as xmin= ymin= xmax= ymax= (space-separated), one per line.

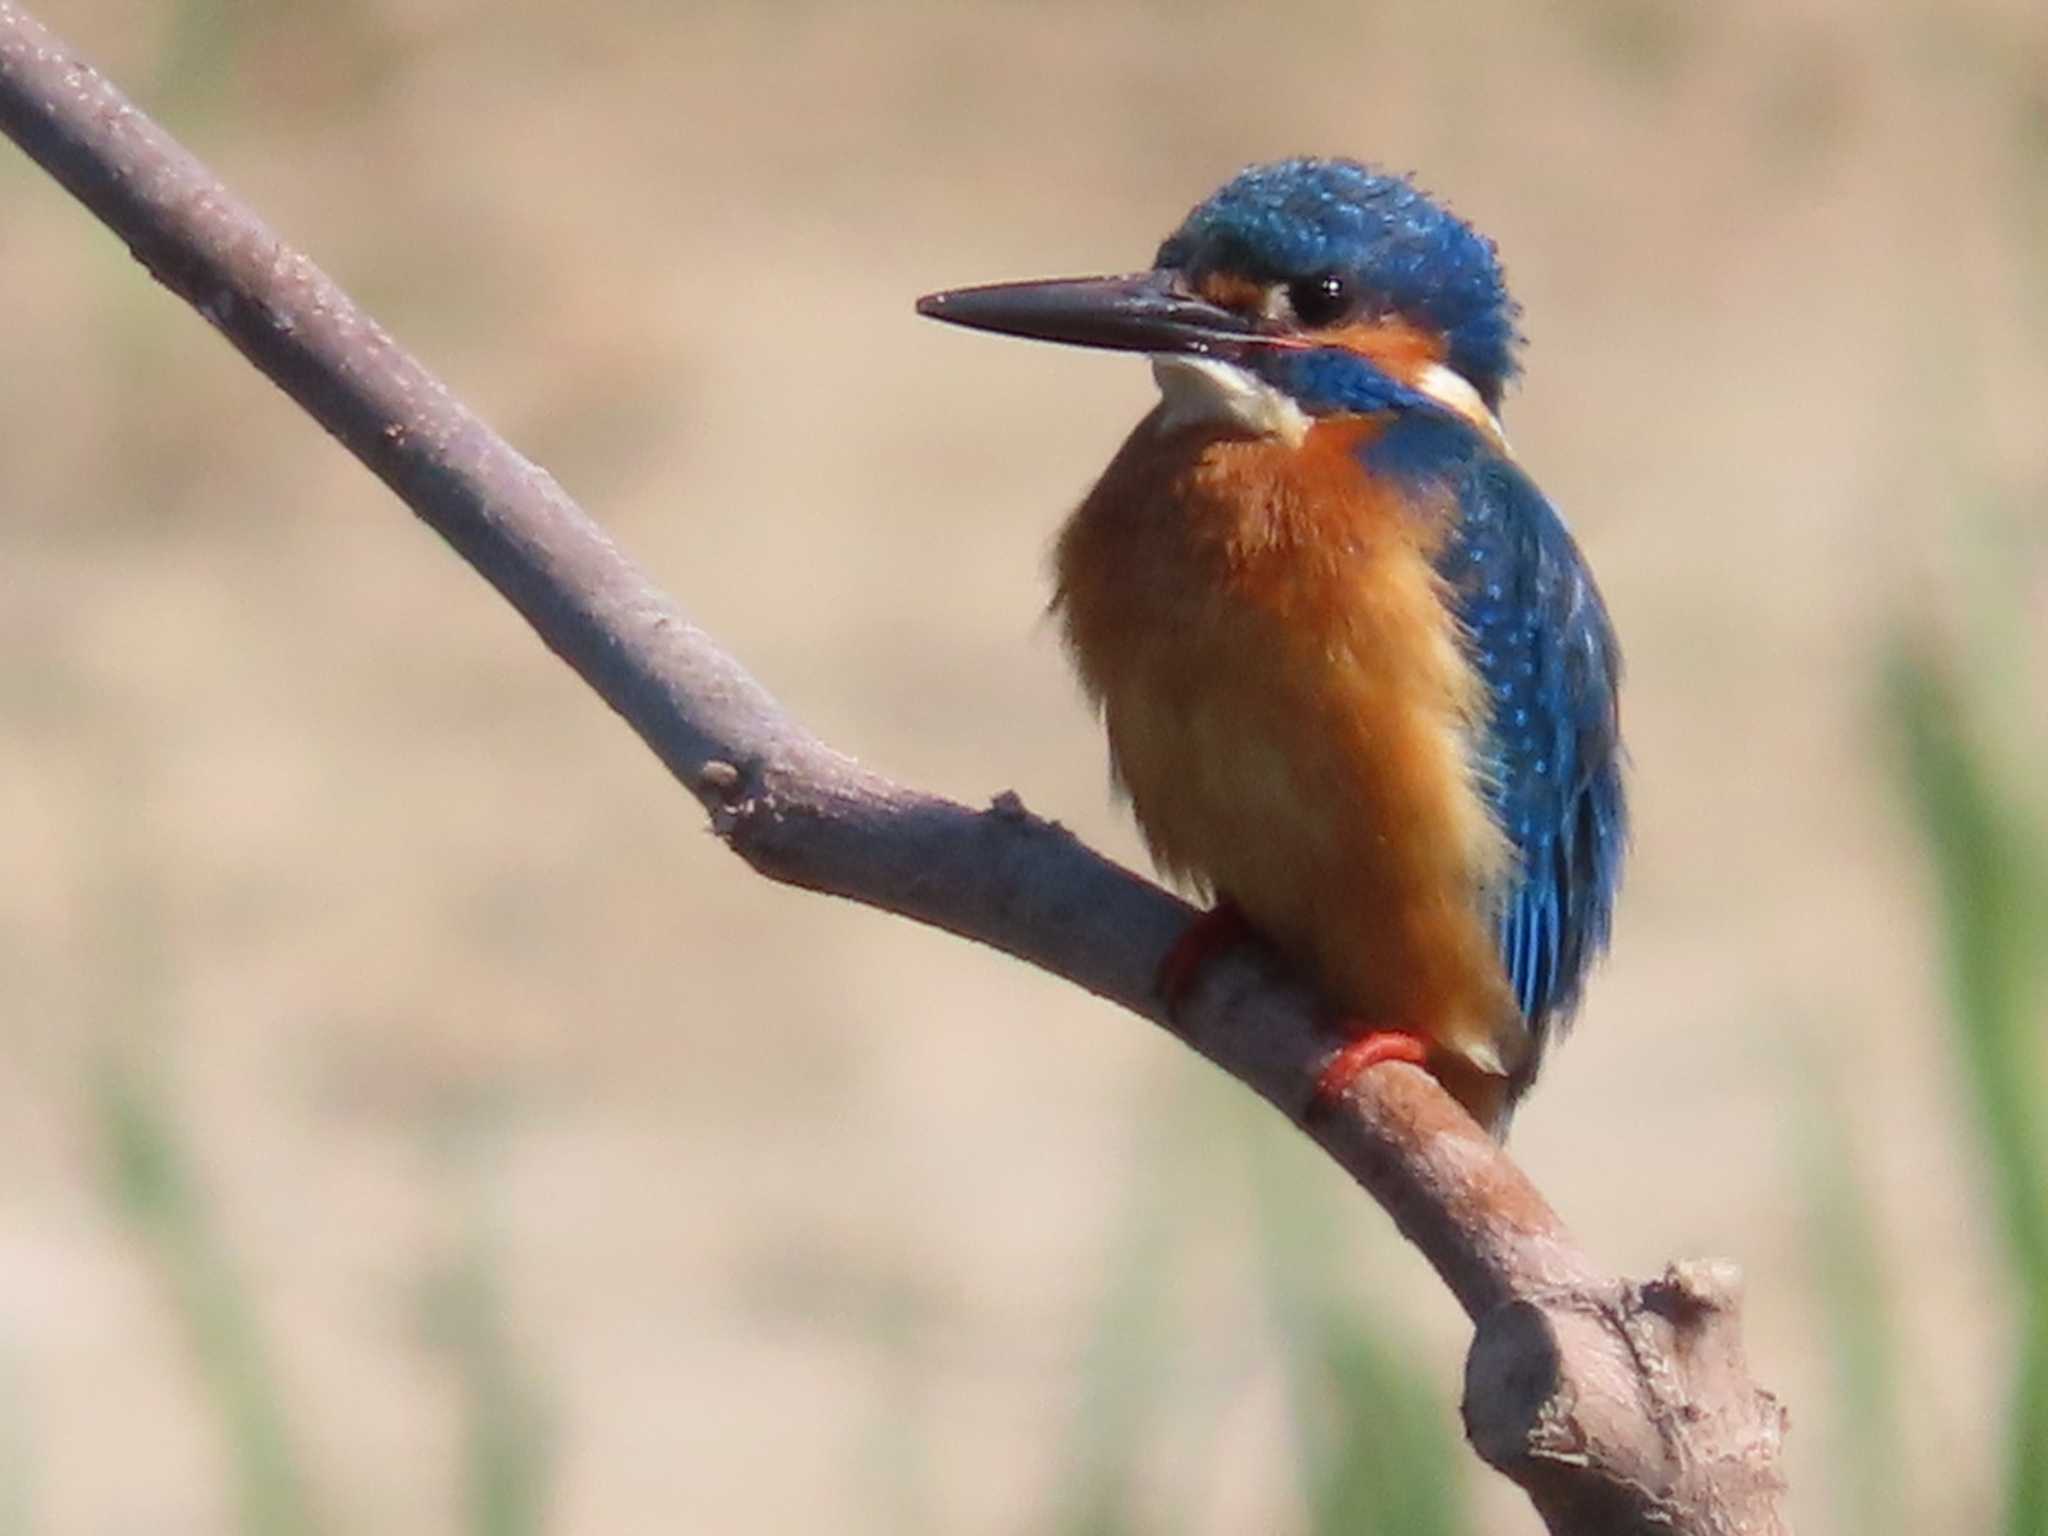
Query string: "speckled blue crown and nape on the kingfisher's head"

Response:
xmin=1155 ymin=160 xmax=1518 ymax=410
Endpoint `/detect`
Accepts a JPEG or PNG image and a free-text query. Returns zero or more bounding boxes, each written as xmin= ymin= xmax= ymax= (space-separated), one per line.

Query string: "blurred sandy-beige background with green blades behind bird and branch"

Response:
xmin=0 ymin=0 xmax=2048 ymax=1536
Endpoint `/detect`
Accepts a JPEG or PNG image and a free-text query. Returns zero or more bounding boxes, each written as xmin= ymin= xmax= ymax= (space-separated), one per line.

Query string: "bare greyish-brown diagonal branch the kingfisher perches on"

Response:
xmin=0 ymin=0 xmax=1784 ymax=1536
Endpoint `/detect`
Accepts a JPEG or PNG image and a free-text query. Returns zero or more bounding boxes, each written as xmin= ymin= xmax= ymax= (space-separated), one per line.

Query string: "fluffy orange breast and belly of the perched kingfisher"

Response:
xmin=1055 ymin=403 xmax=1524 ymax=1077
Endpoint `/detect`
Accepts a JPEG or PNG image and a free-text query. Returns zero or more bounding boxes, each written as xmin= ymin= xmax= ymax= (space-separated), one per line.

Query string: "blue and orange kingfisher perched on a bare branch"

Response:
xmin=918 ymin=158 xmax=1628 ymax=1137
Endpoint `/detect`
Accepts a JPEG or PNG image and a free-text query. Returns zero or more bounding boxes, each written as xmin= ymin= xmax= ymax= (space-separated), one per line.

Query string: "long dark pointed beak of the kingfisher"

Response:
xmin=918 ymin=272 xmax=1257 ymax=356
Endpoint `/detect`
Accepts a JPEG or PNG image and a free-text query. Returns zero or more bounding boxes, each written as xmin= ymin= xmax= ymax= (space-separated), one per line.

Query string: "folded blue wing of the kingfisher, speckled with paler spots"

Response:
xmin=1374 ymin=418 xmax=1628 ymax=1096
